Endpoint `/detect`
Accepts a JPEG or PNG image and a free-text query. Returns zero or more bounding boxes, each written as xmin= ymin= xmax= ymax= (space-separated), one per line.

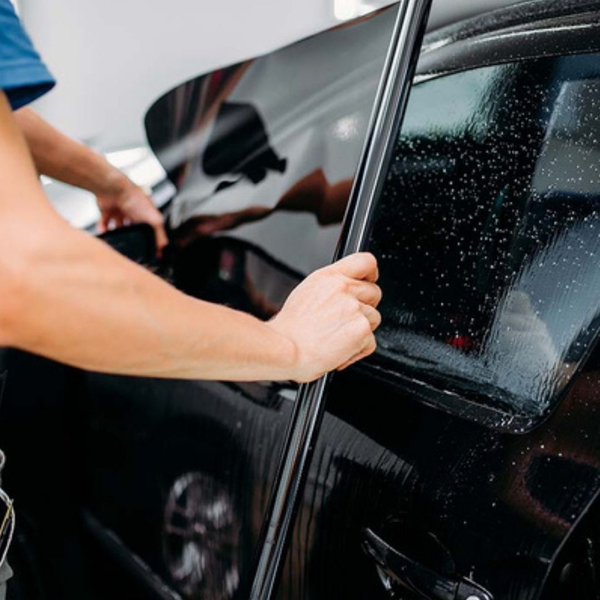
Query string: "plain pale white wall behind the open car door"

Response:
xmin=19 ymin=0 xmax=515 ymax=149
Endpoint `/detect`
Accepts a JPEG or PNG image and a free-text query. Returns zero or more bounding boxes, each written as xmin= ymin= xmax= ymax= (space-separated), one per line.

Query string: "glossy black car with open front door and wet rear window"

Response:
xmin=0 ymin=0 xmax=600 ymax=600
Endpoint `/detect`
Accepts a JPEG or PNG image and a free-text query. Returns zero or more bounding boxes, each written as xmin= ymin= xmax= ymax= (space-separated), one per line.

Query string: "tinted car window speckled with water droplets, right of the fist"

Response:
xmin=370 ymin=55 xmax=600 ymax=418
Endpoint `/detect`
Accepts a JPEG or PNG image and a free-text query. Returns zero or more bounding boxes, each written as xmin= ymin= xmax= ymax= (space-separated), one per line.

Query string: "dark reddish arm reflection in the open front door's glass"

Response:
xmin=173 ymin=169 xmax=353 ymax=245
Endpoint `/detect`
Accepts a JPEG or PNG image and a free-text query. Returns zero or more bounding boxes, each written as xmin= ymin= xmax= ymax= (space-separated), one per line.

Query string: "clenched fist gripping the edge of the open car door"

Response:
xmin=268 ymin=253 xmax=381 ymax=383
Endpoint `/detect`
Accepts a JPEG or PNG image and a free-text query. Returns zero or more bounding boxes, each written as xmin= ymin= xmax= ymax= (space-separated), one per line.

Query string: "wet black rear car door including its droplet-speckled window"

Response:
xmin=266 ymin=23 xmax=600 ymax=600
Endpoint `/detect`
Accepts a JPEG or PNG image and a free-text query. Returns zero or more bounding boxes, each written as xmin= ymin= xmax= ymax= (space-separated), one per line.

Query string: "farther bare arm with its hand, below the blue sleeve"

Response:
xmin=14 ymin=108 xmax=167 ymax=250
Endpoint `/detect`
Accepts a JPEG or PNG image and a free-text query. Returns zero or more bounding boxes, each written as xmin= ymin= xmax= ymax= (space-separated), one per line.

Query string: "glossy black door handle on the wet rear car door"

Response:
xmin=363 ymin=529 xmax=493 ymax=600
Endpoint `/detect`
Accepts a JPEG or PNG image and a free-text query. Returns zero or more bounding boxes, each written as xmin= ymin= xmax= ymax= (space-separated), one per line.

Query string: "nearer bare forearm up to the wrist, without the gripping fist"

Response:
xmin=0 ymin=92 xmax=297 ymax=380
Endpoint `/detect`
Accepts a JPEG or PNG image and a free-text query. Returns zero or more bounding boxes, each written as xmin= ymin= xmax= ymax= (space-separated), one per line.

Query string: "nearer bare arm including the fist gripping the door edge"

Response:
xmin=0 ymin=93 xmax=380 ymax=381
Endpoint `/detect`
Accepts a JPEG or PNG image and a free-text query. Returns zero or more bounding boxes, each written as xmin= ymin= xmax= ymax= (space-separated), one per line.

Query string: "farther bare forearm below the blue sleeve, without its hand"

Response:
xmin=15 ymin=108 xmax=128 ymax=195
